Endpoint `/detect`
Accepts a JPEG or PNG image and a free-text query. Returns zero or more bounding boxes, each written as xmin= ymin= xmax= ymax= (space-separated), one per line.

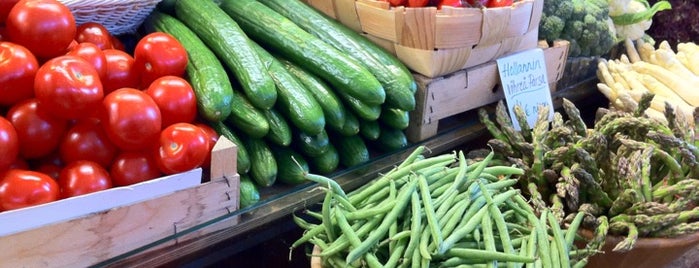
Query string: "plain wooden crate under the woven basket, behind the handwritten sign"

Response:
xmin=406 ymin=41 xmax=569 ymax=142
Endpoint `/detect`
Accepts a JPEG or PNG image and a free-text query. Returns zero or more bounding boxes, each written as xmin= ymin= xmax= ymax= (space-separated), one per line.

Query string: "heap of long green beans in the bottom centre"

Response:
xmin=292 ymin=147 xmax=588 ymax=267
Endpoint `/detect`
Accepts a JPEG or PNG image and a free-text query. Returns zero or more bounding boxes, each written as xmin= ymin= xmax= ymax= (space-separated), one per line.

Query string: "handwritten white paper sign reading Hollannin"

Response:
xmin=497 ymin=48 xmax=553 ymax=130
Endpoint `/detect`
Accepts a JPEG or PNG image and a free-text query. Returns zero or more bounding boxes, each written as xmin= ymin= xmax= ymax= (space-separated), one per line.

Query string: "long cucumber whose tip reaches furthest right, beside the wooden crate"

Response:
xmin=260 ymin=0 xmax=417 ymax=111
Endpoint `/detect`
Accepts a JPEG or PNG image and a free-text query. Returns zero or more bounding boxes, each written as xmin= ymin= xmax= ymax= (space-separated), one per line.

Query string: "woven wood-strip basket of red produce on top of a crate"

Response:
xmin=304 ymin=0 xmax=544 ymax=77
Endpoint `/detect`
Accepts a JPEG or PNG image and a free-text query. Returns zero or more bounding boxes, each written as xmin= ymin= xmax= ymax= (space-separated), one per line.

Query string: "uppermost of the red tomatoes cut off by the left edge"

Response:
xmin=0 ymin=42 xmax=39 ymax=106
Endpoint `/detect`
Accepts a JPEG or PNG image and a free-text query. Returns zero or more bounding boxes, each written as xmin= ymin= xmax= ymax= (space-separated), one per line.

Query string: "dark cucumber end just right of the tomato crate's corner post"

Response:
xmin=243 ymin=137 xmax=278 ymax=187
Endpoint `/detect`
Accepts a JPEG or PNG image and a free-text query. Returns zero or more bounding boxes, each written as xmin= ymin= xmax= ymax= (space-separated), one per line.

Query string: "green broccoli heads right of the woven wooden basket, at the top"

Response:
xmin=539 ymin=0 xmax=617 ymax=57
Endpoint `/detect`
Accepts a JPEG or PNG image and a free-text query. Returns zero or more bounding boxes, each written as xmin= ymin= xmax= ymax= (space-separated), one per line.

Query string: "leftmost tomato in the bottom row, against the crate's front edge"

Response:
xmin=0 ymin=169 xmax=60 ymax=211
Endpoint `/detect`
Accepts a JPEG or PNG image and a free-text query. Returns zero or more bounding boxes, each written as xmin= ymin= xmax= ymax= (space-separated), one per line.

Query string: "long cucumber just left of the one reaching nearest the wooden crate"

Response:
xmin=220 ymin=0 xmax=386 ymax=105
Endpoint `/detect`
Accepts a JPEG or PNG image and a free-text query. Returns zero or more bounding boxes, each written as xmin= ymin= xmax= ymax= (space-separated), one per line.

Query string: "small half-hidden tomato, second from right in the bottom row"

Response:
xmin=109 ymin=151 xmax=162 ymax=186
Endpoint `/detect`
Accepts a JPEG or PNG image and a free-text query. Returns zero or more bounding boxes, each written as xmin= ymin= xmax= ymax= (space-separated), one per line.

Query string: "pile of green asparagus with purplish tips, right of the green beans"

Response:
xmin=479 ymin=94 xmax=699 ymax=252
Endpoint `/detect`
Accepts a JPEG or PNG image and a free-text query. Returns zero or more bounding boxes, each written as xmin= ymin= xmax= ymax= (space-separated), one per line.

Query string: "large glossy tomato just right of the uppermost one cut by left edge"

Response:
xmin=34 ymin=56 xmax=104 ymax=119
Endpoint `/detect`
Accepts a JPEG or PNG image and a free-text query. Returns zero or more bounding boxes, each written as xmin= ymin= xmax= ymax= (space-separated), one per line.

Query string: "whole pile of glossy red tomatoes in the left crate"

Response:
xmin=0 ymin=0 xmax=217 ymax=211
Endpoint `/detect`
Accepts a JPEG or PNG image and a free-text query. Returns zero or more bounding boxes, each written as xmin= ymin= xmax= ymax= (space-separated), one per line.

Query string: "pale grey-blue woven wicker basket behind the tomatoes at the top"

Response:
xmin=59 ymin=0 xmax=161 ymax=35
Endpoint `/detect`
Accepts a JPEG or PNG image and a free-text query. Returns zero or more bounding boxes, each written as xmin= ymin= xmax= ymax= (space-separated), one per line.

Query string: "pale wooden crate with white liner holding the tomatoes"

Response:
xmin=0 ymin=137 xmax=240 ymax=267
